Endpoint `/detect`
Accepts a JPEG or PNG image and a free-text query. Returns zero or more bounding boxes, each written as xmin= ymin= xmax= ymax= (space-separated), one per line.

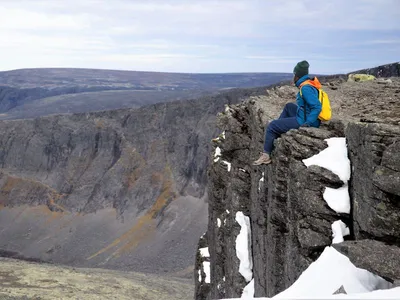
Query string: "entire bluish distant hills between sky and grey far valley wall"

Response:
xmin=0 ymin=69 xmax=292 ymax=120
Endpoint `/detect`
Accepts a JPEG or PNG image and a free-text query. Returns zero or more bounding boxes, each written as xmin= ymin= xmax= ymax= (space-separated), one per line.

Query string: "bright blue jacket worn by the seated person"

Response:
xmin=296 ymin=75 xmax=322 ymax=127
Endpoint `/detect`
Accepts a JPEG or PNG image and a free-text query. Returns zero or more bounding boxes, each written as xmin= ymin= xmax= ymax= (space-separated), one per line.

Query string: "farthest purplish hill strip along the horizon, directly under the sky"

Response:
xmin=0 ymin=69 xmax=292 ymax=90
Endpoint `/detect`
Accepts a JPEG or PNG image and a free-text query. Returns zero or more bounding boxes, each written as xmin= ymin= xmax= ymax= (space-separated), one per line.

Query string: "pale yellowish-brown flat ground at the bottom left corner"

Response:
xmin=0 ymin=258 xmax=193 ymax=300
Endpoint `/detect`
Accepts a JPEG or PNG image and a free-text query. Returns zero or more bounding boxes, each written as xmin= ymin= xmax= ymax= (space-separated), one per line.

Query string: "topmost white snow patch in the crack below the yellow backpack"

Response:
xmin=303 ymin=137 xmax=351 ymax=182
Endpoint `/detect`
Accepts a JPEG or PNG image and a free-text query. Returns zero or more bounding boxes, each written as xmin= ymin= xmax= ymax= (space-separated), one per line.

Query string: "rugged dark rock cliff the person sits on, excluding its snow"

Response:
xmin=195 ymin=74 xmax=400 ymax=299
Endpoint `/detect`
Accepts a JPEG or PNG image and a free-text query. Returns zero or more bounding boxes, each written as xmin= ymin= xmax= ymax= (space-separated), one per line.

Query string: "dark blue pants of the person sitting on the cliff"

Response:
xmin=264 ymin=103 xmax=300 ymax=154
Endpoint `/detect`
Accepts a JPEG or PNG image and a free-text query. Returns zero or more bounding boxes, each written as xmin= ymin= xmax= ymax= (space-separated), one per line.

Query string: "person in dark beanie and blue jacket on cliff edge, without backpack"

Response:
xmin=253 ymin=60 xmax=322 ymax=166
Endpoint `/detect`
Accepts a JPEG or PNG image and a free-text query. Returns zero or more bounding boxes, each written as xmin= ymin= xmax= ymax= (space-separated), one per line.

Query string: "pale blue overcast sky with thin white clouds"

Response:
xmin=0 ymin=0 xmax=400 ymax=74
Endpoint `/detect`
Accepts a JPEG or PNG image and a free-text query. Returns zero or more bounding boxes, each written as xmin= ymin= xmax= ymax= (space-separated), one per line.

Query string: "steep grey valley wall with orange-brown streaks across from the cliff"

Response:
xmin=0 ymin=89 xmax=272 ymax=275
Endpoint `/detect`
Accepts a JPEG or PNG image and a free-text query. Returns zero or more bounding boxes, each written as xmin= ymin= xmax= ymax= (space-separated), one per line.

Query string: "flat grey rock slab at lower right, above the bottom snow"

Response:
xmin=333 ymin=240 xmax=400 ymax=281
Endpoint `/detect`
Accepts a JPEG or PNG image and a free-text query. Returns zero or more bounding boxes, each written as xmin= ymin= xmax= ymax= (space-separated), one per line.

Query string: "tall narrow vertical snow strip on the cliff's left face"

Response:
xmin=236 ymin=211 xmax=253 ymax=282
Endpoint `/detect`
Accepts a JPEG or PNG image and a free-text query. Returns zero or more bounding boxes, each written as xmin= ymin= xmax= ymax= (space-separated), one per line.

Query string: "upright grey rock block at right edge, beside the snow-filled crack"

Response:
xmin=346 ymin=123 xmax=400 ymax=243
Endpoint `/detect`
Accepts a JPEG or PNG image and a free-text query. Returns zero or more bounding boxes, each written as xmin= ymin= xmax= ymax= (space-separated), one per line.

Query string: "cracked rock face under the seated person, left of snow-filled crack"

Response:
xmin=255 ymin=123 xmax=347 ymax=296
